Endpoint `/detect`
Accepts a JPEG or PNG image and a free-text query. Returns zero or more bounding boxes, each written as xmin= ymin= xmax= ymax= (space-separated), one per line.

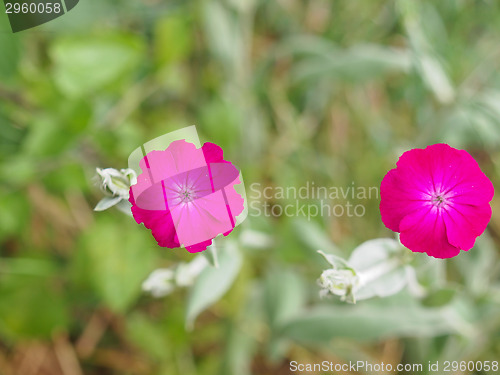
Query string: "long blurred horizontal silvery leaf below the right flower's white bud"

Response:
xmin=281 ymin=293 xmax=462 ymax=345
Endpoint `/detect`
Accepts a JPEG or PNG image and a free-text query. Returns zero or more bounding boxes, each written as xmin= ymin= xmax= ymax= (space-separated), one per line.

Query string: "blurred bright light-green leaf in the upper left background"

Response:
xmin=50 ymin=34 xmax=144 ymax=96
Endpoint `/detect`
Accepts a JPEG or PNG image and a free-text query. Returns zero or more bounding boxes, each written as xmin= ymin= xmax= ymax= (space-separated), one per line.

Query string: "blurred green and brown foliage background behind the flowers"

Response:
xmin=0 ymin=0 xmax=500 ymax=375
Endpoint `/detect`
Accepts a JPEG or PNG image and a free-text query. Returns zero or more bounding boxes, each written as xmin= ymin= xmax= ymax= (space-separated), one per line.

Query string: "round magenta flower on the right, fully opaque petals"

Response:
xmin=380 ymin=144 xmax=494 ymax=258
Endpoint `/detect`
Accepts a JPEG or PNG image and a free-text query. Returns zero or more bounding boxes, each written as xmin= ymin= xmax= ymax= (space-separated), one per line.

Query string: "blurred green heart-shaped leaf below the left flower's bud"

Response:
xmin=80 ymin=217 xmax=155 ymax=312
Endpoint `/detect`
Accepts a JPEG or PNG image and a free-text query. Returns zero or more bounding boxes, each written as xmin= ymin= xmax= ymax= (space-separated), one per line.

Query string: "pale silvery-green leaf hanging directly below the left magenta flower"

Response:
xmin=186 ymin=244 xmax=242 ymax=328
